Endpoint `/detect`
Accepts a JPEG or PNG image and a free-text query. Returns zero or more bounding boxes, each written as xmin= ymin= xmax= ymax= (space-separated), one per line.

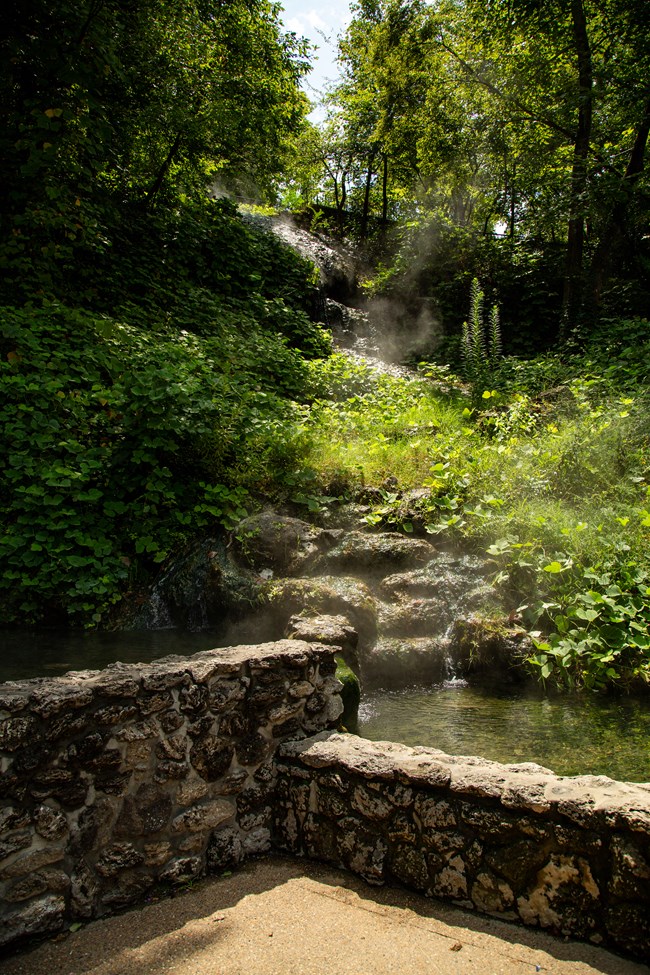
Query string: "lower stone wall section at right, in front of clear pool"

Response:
xmin=274 ymin=734 xmax=650 ymax=961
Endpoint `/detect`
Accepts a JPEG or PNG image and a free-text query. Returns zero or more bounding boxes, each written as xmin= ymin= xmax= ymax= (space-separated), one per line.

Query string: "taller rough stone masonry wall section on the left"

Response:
xmin=0 ymin=640 xmax=342 ymax=945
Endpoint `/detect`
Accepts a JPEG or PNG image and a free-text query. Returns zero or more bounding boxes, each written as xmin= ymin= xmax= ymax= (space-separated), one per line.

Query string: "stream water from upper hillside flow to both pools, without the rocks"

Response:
xmin=5 ymin=221 xmax=650 ymax=782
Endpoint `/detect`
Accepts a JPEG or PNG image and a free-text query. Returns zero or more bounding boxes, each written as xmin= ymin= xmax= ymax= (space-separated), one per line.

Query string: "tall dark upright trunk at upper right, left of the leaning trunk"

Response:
xmin=562 ymin=0 xmax=593 ymax=331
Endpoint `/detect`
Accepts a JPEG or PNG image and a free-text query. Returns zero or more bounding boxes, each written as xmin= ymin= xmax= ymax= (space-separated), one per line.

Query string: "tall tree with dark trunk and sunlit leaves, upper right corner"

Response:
xmin=443 ymin=0 xmax=650 ymax=325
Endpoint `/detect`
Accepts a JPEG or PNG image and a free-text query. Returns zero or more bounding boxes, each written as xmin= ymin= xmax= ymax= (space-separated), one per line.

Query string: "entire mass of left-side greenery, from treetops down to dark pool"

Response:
xmin=0 ymin=0 xmax=329 ymax=624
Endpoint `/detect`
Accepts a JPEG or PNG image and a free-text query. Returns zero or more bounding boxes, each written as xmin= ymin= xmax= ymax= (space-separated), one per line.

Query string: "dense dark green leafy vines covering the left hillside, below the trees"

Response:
xmin=0 ymin=203 xmax=329 ymax=621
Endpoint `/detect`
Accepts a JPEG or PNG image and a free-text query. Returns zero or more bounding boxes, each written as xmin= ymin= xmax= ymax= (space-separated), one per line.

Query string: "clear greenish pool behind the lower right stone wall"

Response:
xmin=355 ymin=683 xmax=650 ymax=782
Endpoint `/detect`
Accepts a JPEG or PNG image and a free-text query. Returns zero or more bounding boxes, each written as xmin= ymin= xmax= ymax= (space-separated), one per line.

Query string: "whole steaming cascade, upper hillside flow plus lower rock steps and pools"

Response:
xmin=0 ymin=217 xmax=650 ymax=781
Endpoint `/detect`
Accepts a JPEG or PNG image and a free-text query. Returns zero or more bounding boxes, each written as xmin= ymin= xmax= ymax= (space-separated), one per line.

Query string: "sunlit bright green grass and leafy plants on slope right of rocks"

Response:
xmin=298 ymin=355 xmax=650 ymax=689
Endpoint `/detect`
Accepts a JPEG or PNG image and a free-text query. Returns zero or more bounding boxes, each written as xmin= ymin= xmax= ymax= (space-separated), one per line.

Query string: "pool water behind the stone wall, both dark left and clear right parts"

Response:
xmin=5 ymin=627 xmax=650 ymax=782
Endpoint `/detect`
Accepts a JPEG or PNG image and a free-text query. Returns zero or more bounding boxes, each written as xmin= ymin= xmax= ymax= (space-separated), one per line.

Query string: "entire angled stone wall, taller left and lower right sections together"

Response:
xmin=0 ymin=640 xmax=650 ymax=960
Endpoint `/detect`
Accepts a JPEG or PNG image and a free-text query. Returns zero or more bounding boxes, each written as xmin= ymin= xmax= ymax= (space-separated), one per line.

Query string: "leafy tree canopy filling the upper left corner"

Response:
xmin=0 ymin=0 xmax=308 ymax=300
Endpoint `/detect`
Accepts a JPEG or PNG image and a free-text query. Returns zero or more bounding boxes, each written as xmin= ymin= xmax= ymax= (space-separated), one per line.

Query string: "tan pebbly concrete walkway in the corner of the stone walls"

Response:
xmin=0 ymin=857 xmax=650 ymax=975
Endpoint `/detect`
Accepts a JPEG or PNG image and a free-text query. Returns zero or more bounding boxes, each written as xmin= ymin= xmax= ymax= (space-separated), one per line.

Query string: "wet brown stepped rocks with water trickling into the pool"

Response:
xmin=125 ymin=506 xmax=516 ymax=692
